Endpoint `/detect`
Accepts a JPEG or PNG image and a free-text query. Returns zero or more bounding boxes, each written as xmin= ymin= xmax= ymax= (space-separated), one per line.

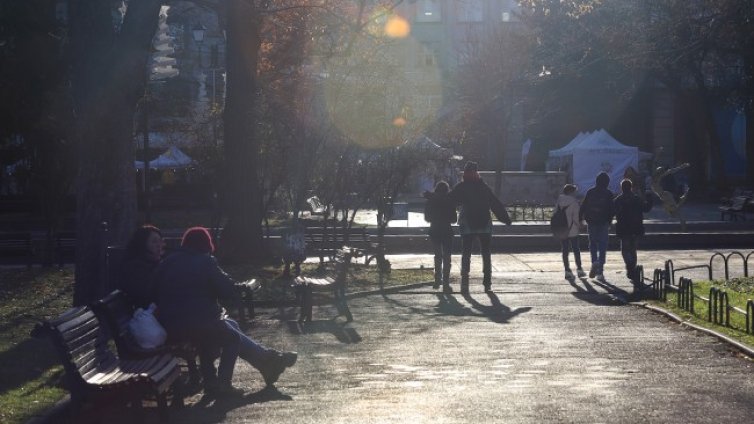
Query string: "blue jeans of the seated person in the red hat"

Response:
xmin=195 ymin=318 xmax=275 ymax=384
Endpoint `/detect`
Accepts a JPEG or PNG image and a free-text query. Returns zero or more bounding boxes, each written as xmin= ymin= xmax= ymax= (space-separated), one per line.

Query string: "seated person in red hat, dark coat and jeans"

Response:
xmin=153 ymin=227 xmax=297 ymax=396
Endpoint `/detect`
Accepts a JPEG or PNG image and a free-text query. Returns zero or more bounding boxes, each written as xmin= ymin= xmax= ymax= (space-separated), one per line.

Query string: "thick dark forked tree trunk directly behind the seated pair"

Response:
xmin=69 ymin=0 xmax=161 ymax=305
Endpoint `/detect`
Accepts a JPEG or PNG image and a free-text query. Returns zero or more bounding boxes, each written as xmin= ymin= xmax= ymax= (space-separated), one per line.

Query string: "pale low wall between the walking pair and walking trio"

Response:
xmin=479 ymin=171 xmax=567 ymax=205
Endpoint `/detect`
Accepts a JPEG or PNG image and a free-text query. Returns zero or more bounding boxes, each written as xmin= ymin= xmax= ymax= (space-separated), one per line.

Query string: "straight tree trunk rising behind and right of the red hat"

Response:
xmin=219 ymin=0 xmax=267 ymax=263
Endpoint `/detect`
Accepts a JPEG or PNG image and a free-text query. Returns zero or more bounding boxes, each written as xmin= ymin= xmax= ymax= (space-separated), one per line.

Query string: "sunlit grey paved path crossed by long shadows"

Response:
xmin=152 ymin=251 xmax=754 ymax=423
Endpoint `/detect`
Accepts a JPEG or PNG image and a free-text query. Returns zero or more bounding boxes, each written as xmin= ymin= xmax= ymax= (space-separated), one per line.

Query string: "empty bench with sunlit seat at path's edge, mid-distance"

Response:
xmin=293 ymin=246 xmax=360 ymax=322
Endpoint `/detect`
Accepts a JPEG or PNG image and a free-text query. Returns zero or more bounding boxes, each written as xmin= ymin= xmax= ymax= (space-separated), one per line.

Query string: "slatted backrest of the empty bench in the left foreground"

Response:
xmin=37 ymin=306 xmax=118 ymax=386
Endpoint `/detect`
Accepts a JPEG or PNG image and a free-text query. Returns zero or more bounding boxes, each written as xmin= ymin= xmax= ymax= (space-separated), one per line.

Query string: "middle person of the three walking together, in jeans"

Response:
xmin=579 ymin=172 xmax=615 ymax=281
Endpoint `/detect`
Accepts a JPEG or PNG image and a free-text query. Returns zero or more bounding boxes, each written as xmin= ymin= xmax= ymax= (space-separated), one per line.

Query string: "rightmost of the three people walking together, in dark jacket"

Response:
xmin=613 ymin=179 xmax=652 ymax=284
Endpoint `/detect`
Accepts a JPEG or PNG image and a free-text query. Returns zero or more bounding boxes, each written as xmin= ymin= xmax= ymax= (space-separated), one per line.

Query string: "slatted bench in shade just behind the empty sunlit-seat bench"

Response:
xmin=305 ymin=227 xmax=373 ymax=267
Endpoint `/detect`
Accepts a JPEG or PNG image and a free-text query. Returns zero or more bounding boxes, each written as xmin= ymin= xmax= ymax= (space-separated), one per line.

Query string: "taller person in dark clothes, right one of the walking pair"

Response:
xmin=448 ymin=162 xmax=511 ymax=294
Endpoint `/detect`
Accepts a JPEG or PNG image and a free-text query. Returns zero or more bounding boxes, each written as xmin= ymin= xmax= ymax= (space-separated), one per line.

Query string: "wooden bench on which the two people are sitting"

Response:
xmin=92 ymin=290 xmax=201 ymax=384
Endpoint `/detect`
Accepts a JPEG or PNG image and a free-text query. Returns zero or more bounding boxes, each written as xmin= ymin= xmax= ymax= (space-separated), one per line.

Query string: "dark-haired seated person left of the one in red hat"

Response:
xmin=117 ymin=225 xmax=165 ymax=309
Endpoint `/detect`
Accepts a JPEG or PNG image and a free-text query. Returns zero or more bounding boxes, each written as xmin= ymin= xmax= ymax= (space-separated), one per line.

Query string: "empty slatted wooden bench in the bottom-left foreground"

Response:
xmin=32 ymin=306 xmax=180 ymax=422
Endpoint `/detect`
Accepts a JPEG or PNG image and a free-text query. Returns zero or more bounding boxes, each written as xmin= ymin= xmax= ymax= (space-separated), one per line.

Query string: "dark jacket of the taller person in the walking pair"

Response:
xmin=448 ymin=179 xmax=511 ymax=234
